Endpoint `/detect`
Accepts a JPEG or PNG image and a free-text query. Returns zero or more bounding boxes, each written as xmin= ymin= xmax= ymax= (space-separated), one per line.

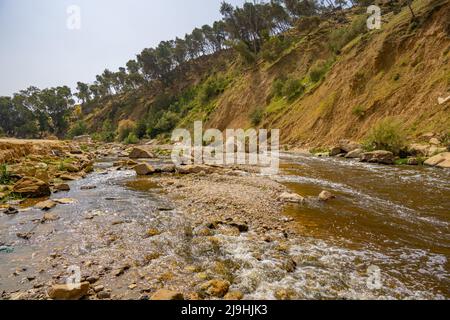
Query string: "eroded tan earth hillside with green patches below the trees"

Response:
xmin=79 ymin=0 xmax=450 ymax=146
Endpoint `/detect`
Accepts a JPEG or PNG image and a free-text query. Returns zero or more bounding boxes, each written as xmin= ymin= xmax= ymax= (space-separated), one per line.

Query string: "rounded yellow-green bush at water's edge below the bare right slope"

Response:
xmin=363 ymin=118 xmax=406 ymax=154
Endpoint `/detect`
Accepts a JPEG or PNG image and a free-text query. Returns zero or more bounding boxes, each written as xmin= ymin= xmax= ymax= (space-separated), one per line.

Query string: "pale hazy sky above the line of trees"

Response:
xmin=0 ymin=0 xmax=245 ymax=96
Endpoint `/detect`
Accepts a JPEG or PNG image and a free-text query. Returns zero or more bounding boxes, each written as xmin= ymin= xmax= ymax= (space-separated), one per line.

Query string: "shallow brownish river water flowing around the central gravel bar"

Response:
xmin=0 ymin=154 xmax=450 ymax=299
